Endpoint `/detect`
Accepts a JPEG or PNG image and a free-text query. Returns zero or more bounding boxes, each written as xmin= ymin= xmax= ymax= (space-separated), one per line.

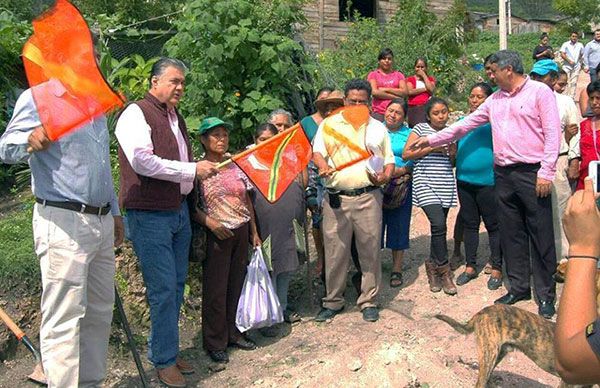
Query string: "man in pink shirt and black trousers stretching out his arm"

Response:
xmin=413 ymin=50 xmax=561 ymax=318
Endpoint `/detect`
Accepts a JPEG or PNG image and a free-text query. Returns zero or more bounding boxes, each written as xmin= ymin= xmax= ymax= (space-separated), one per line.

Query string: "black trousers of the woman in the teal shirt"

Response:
xmin=457 ymin=181 xmax=502 ymax=271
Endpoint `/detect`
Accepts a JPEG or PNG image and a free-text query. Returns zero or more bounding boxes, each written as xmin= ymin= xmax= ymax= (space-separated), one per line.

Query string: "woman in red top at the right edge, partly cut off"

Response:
xmin=577 ymin=80 xmax=600 ymax=190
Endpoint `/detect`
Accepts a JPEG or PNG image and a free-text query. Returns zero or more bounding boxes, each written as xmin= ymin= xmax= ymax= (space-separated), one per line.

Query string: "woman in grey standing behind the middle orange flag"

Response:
xmin=254 ymin=124 xmax=308 ymax=336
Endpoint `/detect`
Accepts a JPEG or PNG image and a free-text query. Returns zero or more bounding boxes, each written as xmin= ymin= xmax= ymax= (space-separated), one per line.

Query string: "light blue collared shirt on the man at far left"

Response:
xmin=0 ymin=86 xmax=120 ymax=215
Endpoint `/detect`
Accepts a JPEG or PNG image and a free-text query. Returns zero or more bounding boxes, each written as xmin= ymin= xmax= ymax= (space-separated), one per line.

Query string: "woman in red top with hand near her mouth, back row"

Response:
xmin=406 ymin=58 xmax=435 ymax=128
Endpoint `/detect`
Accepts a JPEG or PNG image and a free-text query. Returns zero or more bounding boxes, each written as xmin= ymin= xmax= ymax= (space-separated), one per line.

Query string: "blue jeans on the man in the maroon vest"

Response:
xmin=127 ymin=205 xmax=192 ymax=368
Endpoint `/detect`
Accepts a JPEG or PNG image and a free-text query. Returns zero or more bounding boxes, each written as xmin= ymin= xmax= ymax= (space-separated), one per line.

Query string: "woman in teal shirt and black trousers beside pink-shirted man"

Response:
xmin=456 ymin=82 xmax=502 ymax=290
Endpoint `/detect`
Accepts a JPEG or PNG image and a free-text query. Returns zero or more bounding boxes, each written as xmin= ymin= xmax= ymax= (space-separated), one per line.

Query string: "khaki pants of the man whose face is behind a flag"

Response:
xmin=322 ymin=190 xmax=383 ymax=310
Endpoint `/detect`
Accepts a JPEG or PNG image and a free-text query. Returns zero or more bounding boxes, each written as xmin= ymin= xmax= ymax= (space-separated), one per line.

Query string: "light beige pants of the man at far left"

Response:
xmin=33 ymin=204 xmax=115 ymax=388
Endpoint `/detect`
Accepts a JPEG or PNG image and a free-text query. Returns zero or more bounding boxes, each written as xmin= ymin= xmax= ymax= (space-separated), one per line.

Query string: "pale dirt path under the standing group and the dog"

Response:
xmin=0 ymin=209 xmax=559 ymax=388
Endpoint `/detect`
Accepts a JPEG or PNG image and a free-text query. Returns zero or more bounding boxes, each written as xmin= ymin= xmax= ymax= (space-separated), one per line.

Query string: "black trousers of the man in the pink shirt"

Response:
xmin=494 ymin=164 xmax=556 ymax=300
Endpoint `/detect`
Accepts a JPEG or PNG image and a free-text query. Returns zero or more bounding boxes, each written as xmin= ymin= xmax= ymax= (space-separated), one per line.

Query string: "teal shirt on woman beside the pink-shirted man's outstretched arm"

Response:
xmin=456 ymin=123 xmax=495 ymax=186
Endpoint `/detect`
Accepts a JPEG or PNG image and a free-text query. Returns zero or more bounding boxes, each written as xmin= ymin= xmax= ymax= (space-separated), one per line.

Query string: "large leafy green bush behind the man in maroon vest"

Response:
xmin=166 ymin=0 xmax=312 ymax=147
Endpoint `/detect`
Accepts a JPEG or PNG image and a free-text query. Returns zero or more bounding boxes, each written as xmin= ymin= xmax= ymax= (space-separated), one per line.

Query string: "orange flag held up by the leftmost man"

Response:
xmin=23 ymin=0 xmax=123 ymax=140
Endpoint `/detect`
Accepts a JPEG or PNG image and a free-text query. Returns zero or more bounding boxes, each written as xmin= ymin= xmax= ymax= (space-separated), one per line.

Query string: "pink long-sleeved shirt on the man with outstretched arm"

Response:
xmin=428 ymin=77 xmax=561 ymax=181
